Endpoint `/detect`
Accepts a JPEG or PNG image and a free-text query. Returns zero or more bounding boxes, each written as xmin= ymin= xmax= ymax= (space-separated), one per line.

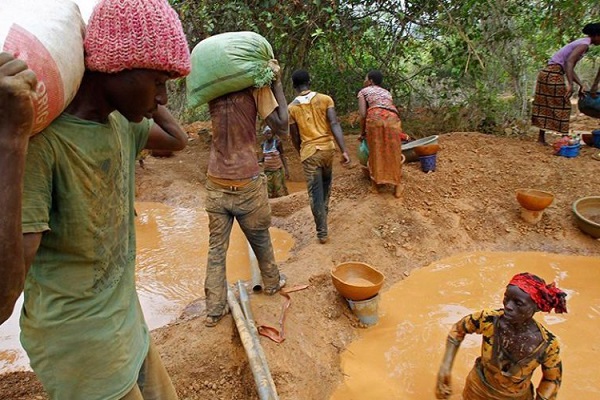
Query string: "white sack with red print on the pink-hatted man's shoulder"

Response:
xmin=0 ymin=0 xmax=85 ymax=134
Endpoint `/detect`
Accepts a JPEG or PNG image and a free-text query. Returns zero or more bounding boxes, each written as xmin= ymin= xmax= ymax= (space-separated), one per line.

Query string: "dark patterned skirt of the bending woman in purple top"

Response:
xmin=531 ymin=64 xmax=571 ymax=133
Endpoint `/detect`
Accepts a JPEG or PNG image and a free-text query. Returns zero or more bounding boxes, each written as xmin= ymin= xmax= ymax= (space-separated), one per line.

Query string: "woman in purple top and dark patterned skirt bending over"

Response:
xmin=531 ymin=23 xmax=600 ymax=144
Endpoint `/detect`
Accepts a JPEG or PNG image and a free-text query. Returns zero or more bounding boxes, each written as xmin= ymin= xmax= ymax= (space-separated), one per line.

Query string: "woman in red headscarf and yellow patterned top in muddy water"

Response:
xmin=435 ymin=273 xmax=567 ymax=400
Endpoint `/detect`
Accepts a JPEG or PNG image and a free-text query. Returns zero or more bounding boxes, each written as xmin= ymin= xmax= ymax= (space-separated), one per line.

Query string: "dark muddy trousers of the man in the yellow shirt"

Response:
xmin=302 ymin=150 xmax=335 ymax=238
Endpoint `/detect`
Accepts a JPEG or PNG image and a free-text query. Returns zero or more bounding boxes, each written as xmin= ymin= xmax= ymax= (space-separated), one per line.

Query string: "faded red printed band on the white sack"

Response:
xmin=4 ymin=24 xmax=65 ymax=133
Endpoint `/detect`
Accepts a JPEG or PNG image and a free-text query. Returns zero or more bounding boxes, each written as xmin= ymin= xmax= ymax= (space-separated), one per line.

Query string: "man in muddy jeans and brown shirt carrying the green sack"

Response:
xmin=203 ymin=53 xmax=288 ymax=327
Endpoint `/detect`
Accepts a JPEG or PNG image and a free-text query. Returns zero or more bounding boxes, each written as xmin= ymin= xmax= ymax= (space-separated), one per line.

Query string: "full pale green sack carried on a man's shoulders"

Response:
xmin=186 ymin=32 xmax=275 ymax=107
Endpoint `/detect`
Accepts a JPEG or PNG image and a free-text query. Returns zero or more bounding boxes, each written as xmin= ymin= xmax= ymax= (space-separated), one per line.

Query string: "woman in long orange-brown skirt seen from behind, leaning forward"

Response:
xmin=357 ymin=70 xmax=407 ymax=198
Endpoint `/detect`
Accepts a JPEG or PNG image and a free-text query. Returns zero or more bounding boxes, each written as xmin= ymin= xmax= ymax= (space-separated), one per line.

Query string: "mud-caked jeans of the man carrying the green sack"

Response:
xmin=204 ymin=174 xmax=279 ymax=316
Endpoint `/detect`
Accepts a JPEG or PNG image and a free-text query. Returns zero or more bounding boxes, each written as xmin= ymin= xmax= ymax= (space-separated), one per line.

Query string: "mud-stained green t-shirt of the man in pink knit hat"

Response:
xmin=21 ymin=112 xmax=151 ymax=400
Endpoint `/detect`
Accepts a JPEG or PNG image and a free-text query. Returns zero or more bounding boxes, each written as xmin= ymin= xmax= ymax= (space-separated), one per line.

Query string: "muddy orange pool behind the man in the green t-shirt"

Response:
xmin=0 ymin=203 xmax=294 ymax=373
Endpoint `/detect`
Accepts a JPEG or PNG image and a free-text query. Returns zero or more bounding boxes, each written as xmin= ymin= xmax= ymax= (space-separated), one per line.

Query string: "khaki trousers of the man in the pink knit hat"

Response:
xmin=121 ymin=341 xmax=178 ymax=400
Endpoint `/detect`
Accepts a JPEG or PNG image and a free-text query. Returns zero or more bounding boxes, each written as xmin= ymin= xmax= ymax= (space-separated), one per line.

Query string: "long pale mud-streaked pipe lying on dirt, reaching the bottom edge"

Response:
xmin=227 ymin=288 xmax=278 ymax=400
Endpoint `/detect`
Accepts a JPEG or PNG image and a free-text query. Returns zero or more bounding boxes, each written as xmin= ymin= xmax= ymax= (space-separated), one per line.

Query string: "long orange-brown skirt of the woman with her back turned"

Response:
xmin=366 ymin=108 xmax=402 ymax=185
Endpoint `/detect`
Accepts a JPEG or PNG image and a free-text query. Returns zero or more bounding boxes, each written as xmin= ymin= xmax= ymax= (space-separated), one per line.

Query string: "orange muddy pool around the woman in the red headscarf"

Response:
xmin=331 ymin=253 xmax=600 ymax=400
